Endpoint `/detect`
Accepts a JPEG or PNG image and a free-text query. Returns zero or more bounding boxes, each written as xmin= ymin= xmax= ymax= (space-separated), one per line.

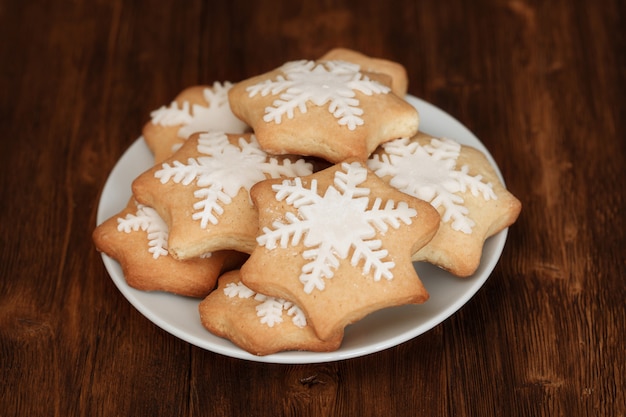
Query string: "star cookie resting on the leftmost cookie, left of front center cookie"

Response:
xmin=132 ymin=132 xmax=312 ymax=259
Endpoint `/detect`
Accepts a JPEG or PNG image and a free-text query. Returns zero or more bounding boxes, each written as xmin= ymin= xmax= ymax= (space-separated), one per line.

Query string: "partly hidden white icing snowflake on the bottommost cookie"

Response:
xmin=224 ymin=282 xmax=306 ymax=328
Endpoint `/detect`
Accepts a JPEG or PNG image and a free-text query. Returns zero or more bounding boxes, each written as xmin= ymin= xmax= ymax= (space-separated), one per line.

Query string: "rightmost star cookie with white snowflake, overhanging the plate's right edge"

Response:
xmin=367 ymin=133 xmax=521 ymax=277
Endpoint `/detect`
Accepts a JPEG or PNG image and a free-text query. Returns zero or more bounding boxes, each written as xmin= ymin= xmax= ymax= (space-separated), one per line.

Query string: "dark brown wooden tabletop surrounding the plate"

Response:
xmin=0 ymin=0 xmax=626 ymax=417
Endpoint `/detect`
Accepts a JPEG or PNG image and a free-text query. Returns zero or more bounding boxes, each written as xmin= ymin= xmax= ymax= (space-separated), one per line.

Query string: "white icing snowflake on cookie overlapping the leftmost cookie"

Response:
xmin=154 ymin=132 xmax=312 ymax=229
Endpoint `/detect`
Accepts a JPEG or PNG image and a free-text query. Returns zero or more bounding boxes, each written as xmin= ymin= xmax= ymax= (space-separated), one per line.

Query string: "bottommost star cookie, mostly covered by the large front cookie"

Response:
xmin=199 ymin=271 xmax=341 ymax=355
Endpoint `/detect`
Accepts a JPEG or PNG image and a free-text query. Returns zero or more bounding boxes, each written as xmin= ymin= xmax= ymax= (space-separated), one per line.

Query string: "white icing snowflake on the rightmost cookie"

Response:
xmin=367 ymin=138 xmax=497 ymax=234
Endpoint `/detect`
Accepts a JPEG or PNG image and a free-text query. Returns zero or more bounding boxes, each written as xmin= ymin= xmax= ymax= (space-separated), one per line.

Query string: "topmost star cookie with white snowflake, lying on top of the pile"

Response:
xmin=229 ymin=60 xmax=419 ymax=163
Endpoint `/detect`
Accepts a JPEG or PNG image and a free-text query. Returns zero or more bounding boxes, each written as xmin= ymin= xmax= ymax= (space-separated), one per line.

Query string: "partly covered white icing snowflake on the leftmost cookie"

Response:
xmin=117 ymin=204 xmax=169 ymax=259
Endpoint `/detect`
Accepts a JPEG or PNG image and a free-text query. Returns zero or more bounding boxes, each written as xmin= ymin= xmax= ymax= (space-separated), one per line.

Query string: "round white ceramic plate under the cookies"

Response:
xmin=97 ymin=96 xmax=507 ymax=363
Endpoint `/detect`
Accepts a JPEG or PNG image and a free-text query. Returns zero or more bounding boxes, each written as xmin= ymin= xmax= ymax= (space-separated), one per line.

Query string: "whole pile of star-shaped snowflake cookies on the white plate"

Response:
xmin=93 ymin=49 xmax=521 ymax=355
